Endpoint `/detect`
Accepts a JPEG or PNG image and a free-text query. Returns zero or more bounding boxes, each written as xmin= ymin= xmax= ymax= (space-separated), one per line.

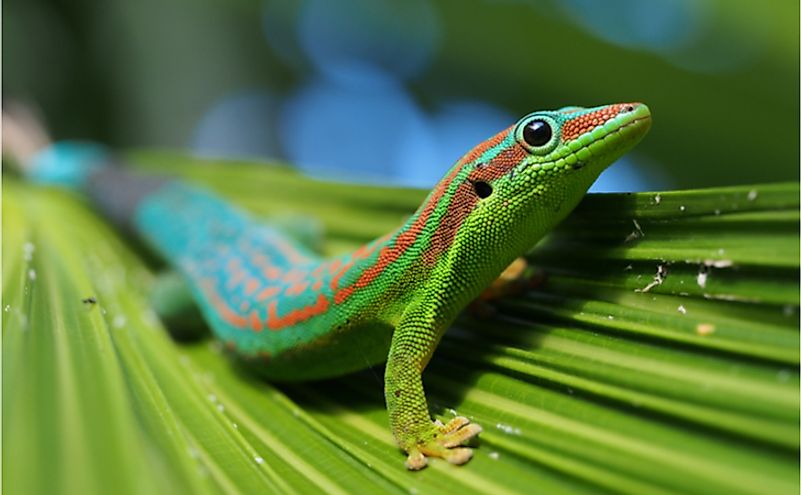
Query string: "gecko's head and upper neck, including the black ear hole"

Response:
xmin=424 ymin=103 xmax=651 ymax=272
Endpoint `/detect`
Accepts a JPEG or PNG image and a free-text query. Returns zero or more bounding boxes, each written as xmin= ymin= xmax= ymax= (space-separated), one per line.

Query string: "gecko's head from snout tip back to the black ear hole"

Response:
xmin=488 ymin=103 xmax=651 ymax=210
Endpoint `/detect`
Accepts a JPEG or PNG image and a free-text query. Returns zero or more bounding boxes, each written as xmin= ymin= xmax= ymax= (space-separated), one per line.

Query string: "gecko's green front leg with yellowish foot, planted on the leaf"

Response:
xmin=384 ymin=316 xmax=481 ymax=470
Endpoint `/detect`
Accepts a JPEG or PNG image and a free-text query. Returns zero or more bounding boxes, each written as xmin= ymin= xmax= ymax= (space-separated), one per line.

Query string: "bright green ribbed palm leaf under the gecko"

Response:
xmin=2 ymin=153 xmax=799 ymax=494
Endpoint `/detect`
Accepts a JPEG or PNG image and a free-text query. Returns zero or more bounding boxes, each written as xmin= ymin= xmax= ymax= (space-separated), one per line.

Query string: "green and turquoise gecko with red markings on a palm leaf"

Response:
xmin=17 ymin=103 xmax=651 ymax=470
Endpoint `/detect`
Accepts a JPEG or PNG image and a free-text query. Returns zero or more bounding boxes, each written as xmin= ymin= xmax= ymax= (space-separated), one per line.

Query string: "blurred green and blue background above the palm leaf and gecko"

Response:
xmin=3 ymin=0 xmax=799 ymax=191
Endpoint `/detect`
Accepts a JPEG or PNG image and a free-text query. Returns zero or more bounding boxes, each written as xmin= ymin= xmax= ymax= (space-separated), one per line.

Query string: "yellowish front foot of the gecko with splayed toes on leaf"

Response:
xmin=406 ymin=416 xmax=481 ymax=471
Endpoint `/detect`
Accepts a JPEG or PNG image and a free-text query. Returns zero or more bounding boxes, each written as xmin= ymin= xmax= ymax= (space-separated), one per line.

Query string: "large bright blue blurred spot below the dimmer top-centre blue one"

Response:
xmin=280 ymin=66 xmax=436 ymax=182
